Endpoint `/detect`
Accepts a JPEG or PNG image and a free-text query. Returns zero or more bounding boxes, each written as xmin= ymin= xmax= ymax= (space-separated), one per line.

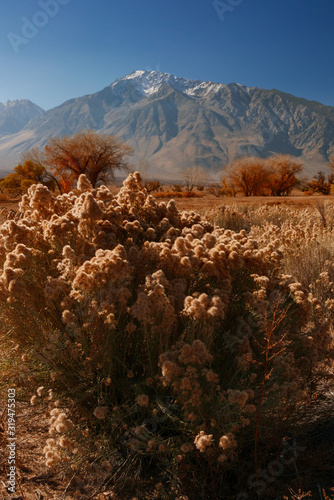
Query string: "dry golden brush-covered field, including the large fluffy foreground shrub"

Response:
xmin=0 ymin=178 xmax=334 ymax=500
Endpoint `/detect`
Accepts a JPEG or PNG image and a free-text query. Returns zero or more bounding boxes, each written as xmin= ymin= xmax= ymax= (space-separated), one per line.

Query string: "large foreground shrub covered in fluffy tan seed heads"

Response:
xmin=0 ymin=173 xmax=332 ymax=498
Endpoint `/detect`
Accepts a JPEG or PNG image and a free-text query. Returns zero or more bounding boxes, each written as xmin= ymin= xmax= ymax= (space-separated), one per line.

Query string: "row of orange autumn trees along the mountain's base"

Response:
xmin=0 ymin=130 xmax=334 ymax=196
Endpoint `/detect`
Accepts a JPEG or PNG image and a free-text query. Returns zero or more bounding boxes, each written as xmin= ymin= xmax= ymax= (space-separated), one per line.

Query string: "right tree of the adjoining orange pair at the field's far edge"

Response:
xmin=265 ymin=155 xmax=303 ymax=196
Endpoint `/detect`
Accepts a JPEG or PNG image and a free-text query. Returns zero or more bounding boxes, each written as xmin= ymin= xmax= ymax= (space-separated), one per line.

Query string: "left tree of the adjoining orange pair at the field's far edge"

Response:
xmin=227 ymin=156 xmax=269 ymax=196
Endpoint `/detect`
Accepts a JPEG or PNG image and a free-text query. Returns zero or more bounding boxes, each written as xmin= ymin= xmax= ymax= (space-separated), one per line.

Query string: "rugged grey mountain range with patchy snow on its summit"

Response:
xmin=0 ymin=71 xmax=334 ymax=179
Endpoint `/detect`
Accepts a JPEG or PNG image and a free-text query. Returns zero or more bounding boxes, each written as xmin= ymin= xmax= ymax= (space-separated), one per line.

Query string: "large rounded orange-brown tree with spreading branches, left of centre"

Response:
xmin=24 ymin=130 xmax=133 ymax=191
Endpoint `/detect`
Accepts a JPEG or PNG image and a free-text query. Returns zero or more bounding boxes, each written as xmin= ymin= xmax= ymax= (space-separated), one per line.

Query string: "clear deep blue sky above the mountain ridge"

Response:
xmin=0 ymin=0 xmax=334 ymax=109
